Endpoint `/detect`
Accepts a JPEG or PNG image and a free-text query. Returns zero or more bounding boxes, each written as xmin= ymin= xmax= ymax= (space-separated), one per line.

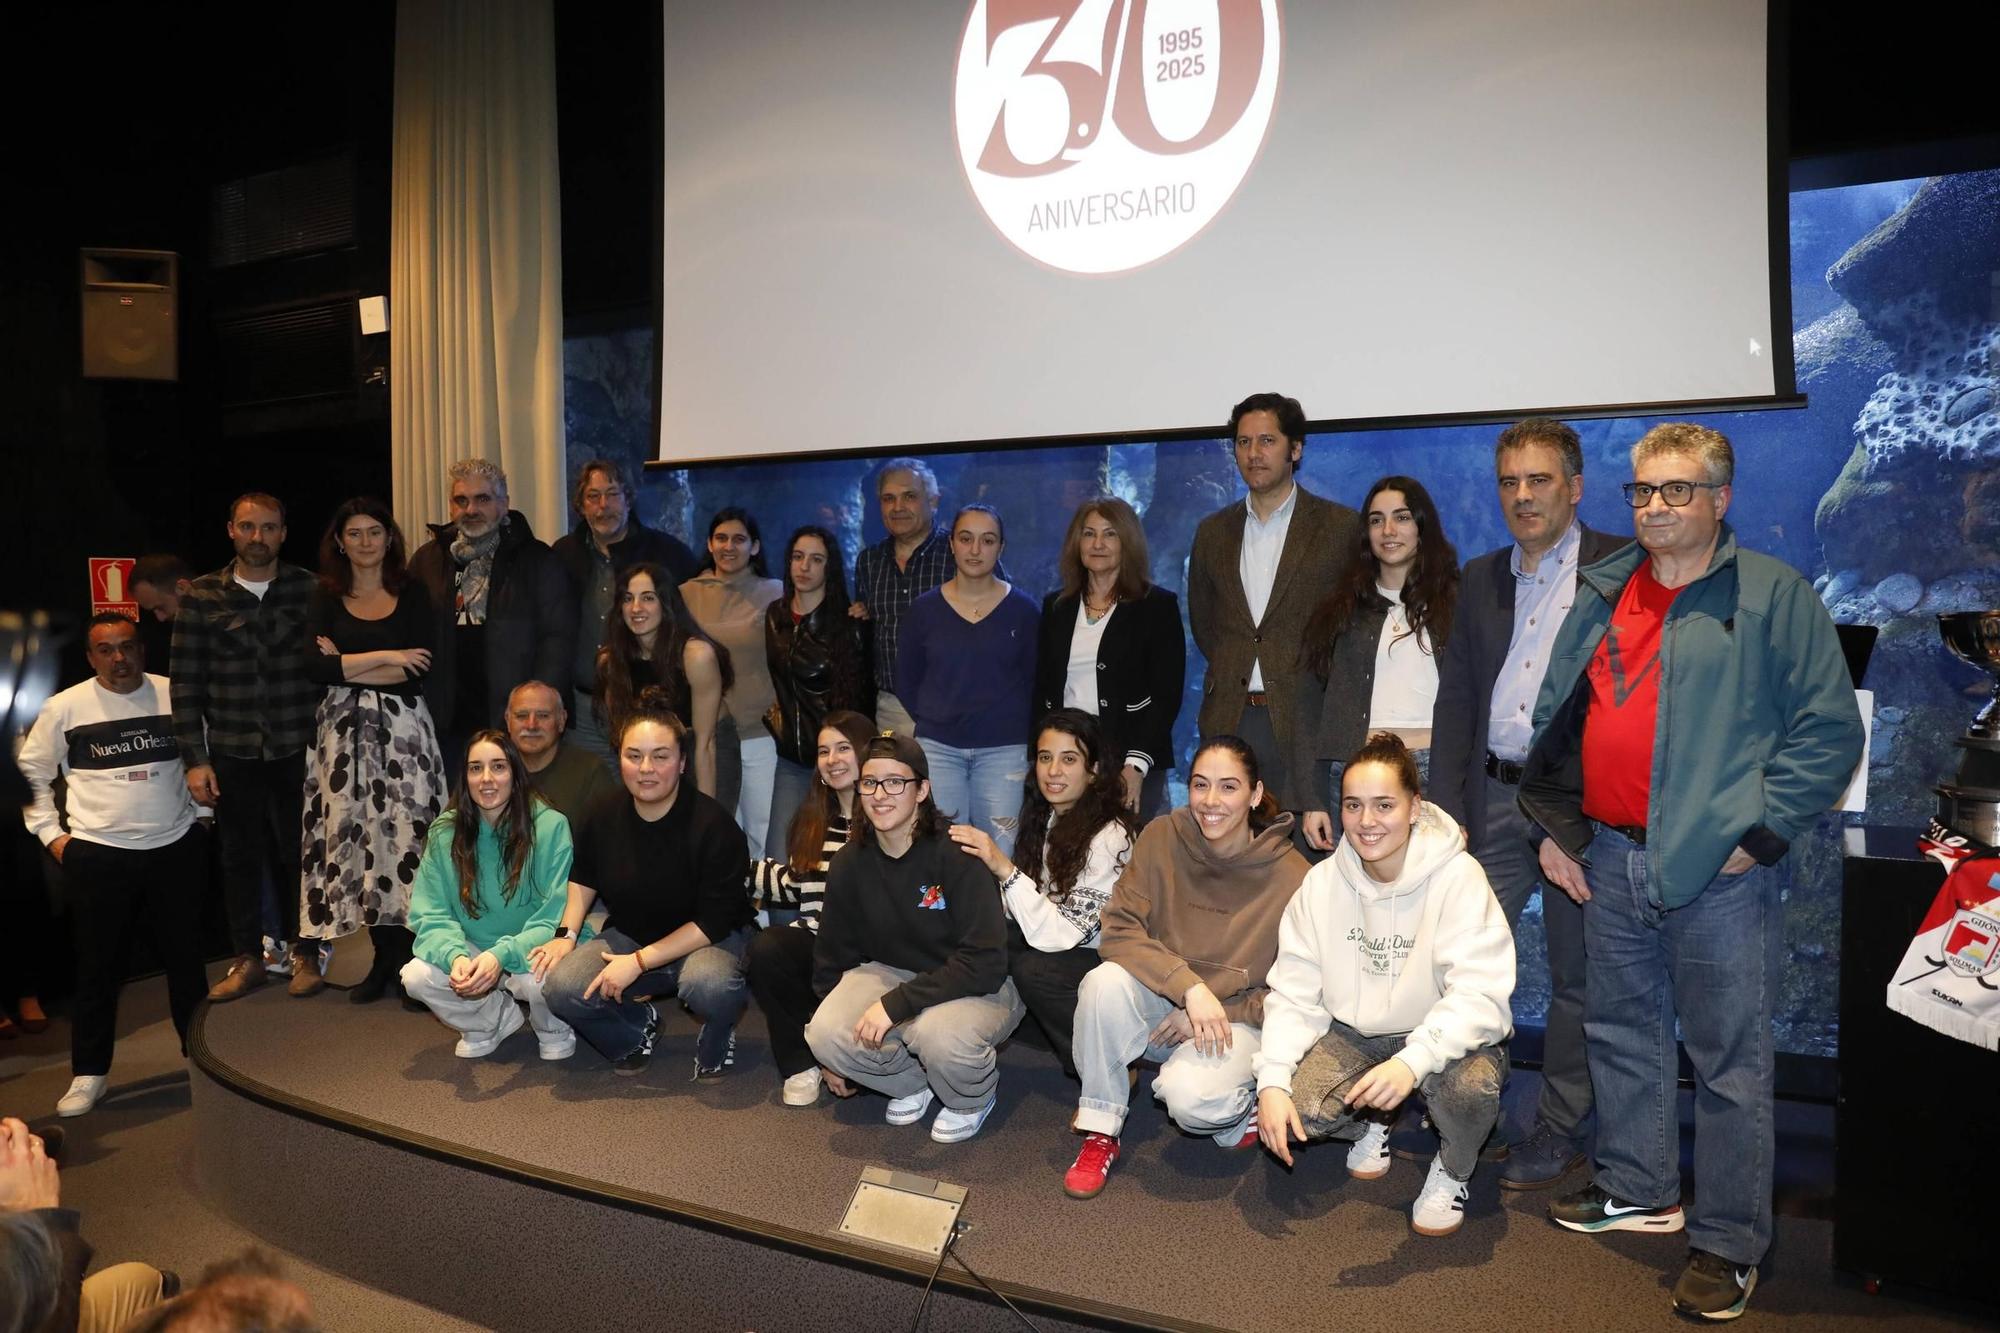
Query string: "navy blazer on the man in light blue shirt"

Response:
xmin=1424 ymin=526 xmax=1630 ymax=851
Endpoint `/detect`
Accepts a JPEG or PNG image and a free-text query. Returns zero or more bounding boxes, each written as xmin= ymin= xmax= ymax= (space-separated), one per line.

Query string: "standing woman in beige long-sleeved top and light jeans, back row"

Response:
xmin=680 ymin=504 xmax=784 ymax=861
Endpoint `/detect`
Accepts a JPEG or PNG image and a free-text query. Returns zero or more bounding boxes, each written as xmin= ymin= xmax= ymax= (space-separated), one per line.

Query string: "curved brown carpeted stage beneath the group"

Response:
xmin=190 ymin=987 xmax=1976 ymax=1331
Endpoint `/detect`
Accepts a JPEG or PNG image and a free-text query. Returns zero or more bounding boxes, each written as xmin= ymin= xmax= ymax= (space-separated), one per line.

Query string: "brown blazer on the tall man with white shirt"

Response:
xmin=1188 ymin=486 xmax=1360 ymax=811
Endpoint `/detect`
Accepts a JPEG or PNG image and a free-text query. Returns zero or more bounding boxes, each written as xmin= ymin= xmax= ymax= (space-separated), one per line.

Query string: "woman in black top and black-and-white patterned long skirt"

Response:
xmin=296 ymin=496 xmax=448 ymax=1005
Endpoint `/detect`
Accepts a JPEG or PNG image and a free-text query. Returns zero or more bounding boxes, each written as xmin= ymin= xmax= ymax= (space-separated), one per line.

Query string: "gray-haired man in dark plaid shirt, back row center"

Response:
xmin=848 ymin=458 xmax=954 ymax=737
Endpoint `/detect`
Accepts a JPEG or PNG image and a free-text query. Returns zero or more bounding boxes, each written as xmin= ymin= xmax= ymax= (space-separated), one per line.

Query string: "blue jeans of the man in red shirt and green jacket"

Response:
xmin=1584 ymin=829 xmax=1788 ymax=1265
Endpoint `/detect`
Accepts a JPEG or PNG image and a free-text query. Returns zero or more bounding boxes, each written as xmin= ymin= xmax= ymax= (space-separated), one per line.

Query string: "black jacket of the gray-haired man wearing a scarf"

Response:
xmin=410 ymin=510 xmax=576 ymax=737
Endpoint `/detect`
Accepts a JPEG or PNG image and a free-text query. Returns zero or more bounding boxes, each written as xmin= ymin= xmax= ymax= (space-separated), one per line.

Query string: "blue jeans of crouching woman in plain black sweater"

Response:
xmin=542 ymin=929 xmax=750 ymax=1061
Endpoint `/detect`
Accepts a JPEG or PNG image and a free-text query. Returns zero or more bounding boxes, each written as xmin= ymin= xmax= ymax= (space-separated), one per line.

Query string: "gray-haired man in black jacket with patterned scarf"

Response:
xmin=410 ymin=458 xmax=576 ymax=771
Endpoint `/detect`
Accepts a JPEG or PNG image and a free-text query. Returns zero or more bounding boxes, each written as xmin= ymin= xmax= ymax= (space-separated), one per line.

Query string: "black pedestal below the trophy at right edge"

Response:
xmin=1834 ymin=829 xmax=2000 ymax=1305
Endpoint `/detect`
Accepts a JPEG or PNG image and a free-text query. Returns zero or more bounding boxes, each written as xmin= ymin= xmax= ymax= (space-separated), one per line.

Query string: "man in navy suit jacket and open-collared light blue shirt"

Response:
xmin=1426 ymin=416 xmax=1626 ymax=1189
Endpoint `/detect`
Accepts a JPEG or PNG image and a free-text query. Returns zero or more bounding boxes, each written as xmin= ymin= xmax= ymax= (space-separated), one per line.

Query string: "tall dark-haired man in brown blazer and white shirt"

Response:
xmin=1188 ymin=394 xmax=1360 ymax=811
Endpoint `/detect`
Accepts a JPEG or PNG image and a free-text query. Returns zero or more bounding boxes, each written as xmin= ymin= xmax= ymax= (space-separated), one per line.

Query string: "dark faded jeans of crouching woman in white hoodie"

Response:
xmin=1292 ymin=1021 xmax=1508 ymax=1181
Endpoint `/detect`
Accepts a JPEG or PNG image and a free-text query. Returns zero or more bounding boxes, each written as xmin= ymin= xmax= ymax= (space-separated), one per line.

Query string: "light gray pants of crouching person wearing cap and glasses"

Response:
xmin=806 ymin=963 xmax=1028 ymax=1111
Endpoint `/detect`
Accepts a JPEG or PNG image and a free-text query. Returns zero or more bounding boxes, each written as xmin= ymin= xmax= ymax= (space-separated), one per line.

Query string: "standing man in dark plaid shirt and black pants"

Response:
xmin=172 ymin=490 xmax=320 ymax=1003
